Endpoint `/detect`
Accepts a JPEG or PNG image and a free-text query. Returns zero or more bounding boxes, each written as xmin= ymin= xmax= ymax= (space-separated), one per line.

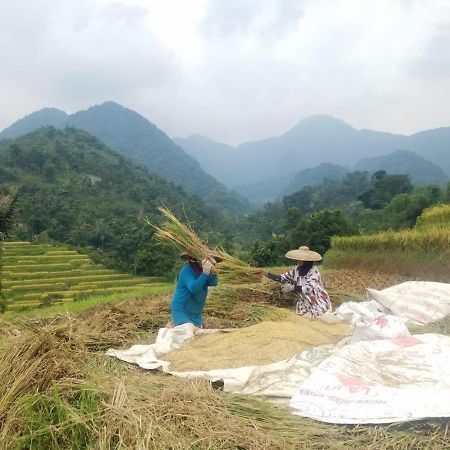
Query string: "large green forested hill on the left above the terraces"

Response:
xmin=0 ymin=127 xmax=226 ymax=272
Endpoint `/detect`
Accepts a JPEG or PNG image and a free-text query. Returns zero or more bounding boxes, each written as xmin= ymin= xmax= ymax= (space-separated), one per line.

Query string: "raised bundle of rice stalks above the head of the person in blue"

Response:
xmin=145 ymin=206 xmax=211 ymax=261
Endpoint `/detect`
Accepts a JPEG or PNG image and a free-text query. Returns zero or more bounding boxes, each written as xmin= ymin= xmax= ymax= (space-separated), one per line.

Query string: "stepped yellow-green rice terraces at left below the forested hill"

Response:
xmin=2 ymin=242 xmax=167 ymax=310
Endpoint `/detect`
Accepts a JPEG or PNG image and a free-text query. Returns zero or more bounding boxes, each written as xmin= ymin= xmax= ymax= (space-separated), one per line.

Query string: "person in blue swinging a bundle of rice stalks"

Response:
xmin=168 ymin=250 xmax=220 ymax=328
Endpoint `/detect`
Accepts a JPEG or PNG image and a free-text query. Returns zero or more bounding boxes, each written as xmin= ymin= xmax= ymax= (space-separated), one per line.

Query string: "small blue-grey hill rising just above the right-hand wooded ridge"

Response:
xmin=353 ymin=150 xmax=449 ymax=186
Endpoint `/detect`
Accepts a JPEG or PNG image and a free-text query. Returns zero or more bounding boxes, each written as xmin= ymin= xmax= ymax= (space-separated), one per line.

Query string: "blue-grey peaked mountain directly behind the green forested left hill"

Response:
xmin=64 ymin=102 xmax=249 ymax=212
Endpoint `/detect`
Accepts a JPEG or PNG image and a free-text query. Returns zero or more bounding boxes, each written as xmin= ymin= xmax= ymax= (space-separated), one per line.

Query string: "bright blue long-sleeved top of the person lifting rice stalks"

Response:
xmin=170 ymin=264 xmax=219 ymax=327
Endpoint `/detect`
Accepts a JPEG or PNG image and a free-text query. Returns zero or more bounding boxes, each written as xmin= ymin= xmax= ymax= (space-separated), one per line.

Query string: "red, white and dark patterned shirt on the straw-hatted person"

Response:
xmin=281 ymin=266 xmax=332 ymax=317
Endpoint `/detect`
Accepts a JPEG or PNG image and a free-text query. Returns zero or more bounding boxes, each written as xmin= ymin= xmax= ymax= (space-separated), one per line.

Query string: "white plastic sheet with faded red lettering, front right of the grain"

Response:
xmin=290 ymin=334 xmax=450 ymax=424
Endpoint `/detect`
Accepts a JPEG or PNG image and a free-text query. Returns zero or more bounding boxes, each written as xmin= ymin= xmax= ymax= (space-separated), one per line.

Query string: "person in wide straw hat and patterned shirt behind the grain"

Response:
xmin=267 ymin=246 xmax=331 ymax=317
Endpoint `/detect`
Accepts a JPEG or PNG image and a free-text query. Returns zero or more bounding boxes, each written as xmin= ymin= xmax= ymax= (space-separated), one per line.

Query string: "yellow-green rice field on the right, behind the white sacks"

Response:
xmin=325 ymin=204 xmax=450 ymax=282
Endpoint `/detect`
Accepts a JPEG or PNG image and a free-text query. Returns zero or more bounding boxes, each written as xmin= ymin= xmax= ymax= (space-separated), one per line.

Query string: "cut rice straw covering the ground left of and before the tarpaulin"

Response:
xmin=0 ymin=282 xmax=450 ymax=450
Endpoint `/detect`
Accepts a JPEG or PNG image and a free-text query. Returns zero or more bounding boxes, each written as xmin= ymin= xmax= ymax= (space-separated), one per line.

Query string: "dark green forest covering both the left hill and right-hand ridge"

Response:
xmin=0 ymin=127 xmax=450 ymax=275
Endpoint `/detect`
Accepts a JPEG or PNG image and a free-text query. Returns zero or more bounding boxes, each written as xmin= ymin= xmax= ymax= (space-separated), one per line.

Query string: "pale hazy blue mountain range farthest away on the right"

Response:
xmin=177 ymin=115 xmax=450 ymax=193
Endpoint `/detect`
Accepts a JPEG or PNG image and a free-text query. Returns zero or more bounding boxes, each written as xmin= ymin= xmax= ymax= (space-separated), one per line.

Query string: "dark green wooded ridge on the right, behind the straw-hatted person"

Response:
xmin=240 ymin=171 xmax=450 ymax=265
